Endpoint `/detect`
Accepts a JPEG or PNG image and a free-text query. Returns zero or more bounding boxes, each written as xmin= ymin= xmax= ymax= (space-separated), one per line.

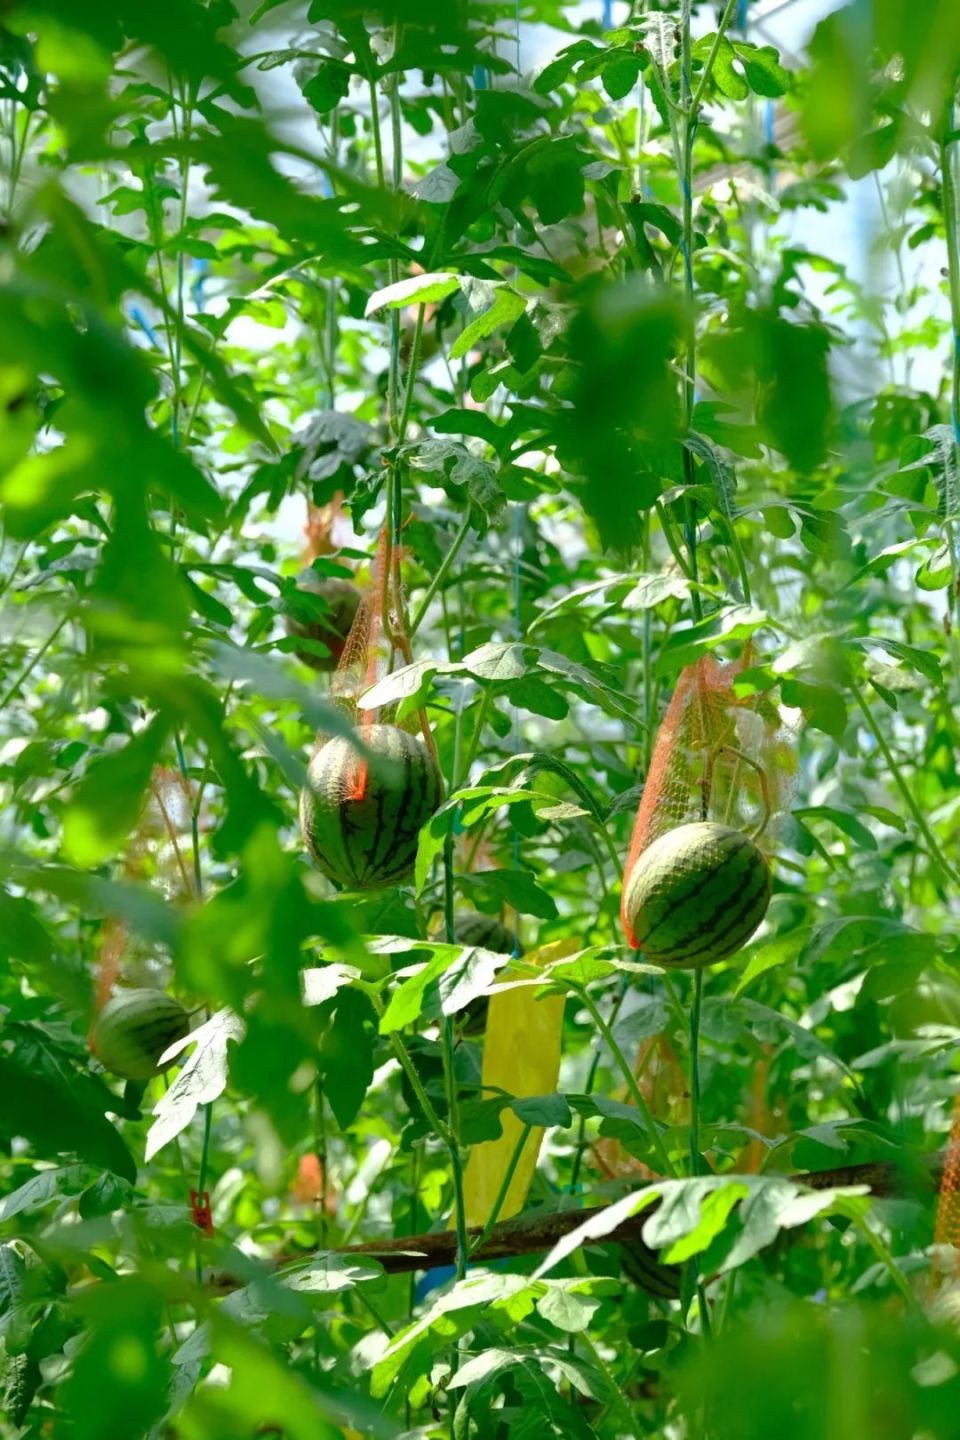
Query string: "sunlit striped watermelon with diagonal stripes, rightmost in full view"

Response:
xmin=623 ymin=821 xmax=770 ymax=969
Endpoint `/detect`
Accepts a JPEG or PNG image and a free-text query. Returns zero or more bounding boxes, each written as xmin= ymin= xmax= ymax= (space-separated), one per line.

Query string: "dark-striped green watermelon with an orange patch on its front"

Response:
xmin=299 ymin=724 xmax=443 ymax=890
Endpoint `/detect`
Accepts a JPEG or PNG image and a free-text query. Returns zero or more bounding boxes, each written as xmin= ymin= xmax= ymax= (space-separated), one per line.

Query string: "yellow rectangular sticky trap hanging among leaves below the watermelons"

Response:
xmin=450 ymin=940 xmax=569 ymax=1228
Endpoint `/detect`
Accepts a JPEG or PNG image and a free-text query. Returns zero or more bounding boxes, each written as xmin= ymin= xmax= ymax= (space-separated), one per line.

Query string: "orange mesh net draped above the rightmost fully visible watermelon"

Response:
xmin=620 ymin=649 xmax=796 ymax=949
